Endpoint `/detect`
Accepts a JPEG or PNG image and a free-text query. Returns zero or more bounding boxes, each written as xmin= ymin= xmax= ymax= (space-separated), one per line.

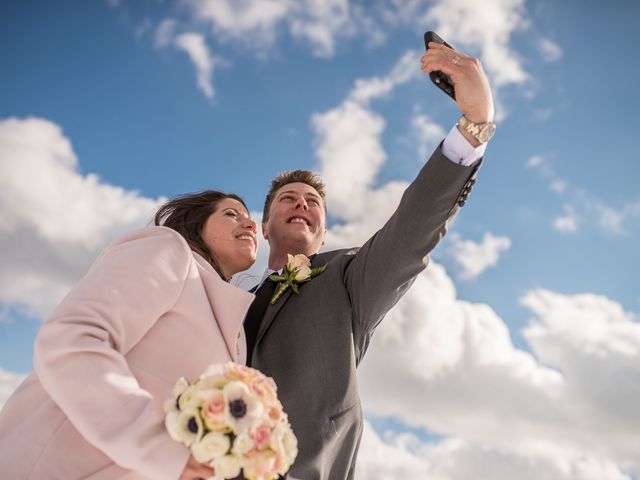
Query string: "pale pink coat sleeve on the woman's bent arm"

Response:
xmin=34 ymin=227 xmax=193 ymax=480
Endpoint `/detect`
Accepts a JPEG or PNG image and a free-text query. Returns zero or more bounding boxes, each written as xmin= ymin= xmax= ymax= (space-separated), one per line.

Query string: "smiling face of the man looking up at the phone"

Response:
xmin=262 ymin=182 xmax=327 ymax=255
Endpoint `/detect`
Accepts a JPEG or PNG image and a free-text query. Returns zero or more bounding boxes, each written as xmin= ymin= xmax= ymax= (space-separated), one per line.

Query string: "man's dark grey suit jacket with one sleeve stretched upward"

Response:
xmin=252 ymin=148 xmax=479 ymax=480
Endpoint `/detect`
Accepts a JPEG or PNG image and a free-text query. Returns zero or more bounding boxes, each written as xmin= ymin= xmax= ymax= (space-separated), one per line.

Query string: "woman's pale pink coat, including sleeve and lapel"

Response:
xmin=0 ymin=227 xmax=253 ymax=480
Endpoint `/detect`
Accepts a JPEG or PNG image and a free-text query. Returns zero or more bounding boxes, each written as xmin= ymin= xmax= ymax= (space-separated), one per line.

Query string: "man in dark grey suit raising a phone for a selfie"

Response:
xmin=245 ymin=44 xmax=495 ymax=480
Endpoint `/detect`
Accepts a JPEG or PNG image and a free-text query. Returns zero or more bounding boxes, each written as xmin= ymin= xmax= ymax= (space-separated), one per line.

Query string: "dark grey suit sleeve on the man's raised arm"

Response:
xmin=344 ymin=147 xmax=480 ymax=335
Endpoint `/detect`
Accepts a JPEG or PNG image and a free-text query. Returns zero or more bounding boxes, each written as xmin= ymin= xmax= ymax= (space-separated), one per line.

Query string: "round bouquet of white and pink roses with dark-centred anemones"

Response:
xmin=165 ymin=362 xmax=298 ymax=480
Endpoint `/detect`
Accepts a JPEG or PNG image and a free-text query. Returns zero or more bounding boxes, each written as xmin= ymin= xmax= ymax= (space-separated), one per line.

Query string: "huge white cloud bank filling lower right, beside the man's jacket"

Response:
xmin=350 ymin=263 xmax=640 ymax=480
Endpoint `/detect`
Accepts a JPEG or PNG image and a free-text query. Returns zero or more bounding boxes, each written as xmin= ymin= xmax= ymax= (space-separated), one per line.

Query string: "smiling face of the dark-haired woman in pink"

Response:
xmin=202 ymin=198 xmax=258 ymax=279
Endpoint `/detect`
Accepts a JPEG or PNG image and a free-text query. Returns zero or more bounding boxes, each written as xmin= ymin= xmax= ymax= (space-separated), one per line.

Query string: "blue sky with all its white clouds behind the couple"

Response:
xmin=0 ymin=0 xmax=640 ymax=479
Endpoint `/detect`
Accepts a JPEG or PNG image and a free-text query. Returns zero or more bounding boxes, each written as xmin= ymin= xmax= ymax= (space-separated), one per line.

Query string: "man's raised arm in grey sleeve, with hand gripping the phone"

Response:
xmin=345 ymin=49 xmax=494 ymax=333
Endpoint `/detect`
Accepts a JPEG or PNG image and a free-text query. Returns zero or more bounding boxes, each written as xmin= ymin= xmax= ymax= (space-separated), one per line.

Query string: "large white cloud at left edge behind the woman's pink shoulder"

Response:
xmin=0 ymin=118 xmax=158 ymax=317
